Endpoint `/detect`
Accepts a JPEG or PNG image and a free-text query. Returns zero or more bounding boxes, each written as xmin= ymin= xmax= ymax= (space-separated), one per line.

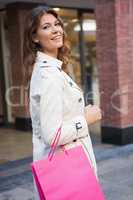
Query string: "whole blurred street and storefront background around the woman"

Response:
xmin=0 ymin=0 xmax=133 ymax=200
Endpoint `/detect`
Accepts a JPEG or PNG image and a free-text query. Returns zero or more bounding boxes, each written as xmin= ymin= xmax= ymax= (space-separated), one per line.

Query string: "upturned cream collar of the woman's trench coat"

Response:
xmin=36 ymin=51 xmax=63 ymax=69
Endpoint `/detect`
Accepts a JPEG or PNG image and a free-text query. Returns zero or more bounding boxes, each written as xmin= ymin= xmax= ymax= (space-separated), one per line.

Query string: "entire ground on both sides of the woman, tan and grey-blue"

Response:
xmin=0 ymin=129 xmax=133 ymax=200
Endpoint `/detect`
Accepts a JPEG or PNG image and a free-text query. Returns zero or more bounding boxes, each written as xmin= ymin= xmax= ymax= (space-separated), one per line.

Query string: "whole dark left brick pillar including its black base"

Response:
xmin=7 ymin=3 xmax=31 ymax=130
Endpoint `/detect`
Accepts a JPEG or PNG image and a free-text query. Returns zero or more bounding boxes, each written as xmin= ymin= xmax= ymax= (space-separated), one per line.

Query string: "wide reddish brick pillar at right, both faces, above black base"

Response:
xmin=96 ymin=0 xmax=133 ymax=142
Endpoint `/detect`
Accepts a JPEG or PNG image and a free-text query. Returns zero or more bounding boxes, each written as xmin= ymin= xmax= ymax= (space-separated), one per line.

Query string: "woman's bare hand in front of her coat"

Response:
xmin=85 ymin=104 xmax=102 ymax=125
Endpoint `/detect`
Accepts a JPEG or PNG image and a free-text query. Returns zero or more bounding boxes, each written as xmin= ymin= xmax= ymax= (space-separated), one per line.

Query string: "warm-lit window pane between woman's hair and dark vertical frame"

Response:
xmin=55 ymin=8 xmax=81 ymax=86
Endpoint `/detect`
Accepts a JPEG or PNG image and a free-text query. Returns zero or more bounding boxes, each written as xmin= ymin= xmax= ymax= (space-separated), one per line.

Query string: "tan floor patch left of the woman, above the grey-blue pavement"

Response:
xmin=0 ymin=128 xmax=32 ymax=164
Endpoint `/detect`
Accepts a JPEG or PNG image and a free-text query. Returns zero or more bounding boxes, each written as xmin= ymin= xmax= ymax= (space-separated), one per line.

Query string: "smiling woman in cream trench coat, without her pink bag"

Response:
xmin=24 ymin=6 xmax=101 ymax=199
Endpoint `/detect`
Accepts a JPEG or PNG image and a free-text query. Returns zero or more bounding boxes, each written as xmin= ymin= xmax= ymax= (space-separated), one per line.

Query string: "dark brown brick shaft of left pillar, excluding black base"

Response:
xmin=7 ymin=4 xmax=28 ymax=118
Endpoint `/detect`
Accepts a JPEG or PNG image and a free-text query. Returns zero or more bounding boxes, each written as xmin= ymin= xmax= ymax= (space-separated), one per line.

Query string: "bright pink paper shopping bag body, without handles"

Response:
xmin=32 ymin=127 xmax=105 ymax=200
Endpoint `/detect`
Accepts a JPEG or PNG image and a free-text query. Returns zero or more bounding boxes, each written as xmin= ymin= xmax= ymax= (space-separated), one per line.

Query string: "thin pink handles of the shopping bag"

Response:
xmin=48 ymin=126 xmax=68 ymax=161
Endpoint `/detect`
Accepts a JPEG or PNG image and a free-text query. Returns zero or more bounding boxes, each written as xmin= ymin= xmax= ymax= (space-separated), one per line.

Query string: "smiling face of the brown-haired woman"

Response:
xmin=35 ymin=13 xmax=64 ymax=53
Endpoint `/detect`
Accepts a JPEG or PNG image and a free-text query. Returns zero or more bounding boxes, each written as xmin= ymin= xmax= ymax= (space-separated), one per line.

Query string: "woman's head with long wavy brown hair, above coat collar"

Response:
xmin=23 ymin=6 xmax=70 ymax=84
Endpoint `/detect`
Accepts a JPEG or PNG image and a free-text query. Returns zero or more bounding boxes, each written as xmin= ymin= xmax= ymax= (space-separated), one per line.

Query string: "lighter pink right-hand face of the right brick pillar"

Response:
xmin=115 ymin=0 xmax=133 ymax=127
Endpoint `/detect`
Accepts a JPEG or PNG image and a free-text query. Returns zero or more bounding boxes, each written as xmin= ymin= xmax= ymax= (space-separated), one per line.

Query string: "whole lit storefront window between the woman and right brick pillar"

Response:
xmin=55 ymin=8 xmax=98 ymax=104
